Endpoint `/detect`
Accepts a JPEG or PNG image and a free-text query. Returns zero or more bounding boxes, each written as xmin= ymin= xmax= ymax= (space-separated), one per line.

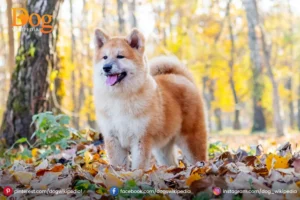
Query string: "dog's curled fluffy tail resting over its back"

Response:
xmin=149 ymin=56 xmax=194 ymax=82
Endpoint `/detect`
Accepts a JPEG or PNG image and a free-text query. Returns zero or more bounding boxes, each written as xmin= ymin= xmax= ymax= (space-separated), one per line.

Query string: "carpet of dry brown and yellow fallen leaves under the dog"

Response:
xmin=0 ymin=134 xmax=300 ymax=200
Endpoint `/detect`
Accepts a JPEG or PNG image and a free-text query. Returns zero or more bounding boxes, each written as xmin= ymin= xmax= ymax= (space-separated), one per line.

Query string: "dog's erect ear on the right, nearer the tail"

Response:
xmin=127 ymin=29 xmax=145 ymax=53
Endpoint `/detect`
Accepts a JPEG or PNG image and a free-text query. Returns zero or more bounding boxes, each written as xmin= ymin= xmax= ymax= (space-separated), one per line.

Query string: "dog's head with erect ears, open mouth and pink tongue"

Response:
xmin=94 ymin=29 xmax=147 ymax=92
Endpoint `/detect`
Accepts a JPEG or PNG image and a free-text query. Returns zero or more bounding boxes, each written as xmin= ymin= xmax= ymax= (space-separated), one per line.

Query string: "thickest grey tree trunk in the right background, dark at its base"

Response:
xmin=243 ymin=0 xmax=266 ymax=132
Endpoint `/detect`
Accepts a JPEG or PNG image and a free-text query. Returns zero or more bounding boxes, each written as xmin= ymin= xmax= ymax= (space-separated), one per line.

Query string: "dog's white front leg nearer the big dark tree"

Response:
xmin=104 ymin=136 xmax=128 ymax=168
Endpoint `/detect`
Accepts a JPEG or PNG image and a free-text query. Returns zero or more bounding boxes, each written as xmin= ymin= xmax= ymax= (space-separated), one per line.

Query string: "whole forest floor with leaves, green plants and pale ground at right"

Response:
xmin=0 ymin=115 xmax=300 ymax=200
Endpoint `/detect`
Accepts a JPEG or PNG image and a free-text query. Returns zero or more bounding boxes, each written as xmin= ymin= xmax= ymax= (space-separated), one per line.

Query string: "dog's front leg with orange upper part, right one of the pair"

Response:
xmin=131 ymin=137 xmax=152 ymax=169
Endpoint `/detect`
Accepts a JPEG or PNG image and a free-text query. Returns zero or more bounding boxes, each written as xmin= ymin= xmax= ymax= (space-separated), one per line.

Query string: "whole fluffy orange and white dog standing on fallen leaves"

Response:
xmin=94 ymin=29 xmax=207 ymax=169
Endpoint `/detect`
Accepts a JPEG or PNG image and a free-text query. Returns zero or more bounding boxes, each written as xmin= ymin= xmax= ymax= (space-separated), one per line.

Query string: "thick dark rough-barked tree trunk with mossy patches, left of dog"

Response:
xmin=0 ymin=0 xmax=59 ymax=145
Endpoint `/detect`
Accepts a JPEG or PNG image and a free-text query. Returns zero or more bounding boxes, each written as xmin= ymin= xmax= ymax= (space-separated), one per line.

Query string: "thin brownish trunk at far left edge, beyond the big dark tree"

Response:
xmin=6 ymin=0 xmax=15 ymax=75
